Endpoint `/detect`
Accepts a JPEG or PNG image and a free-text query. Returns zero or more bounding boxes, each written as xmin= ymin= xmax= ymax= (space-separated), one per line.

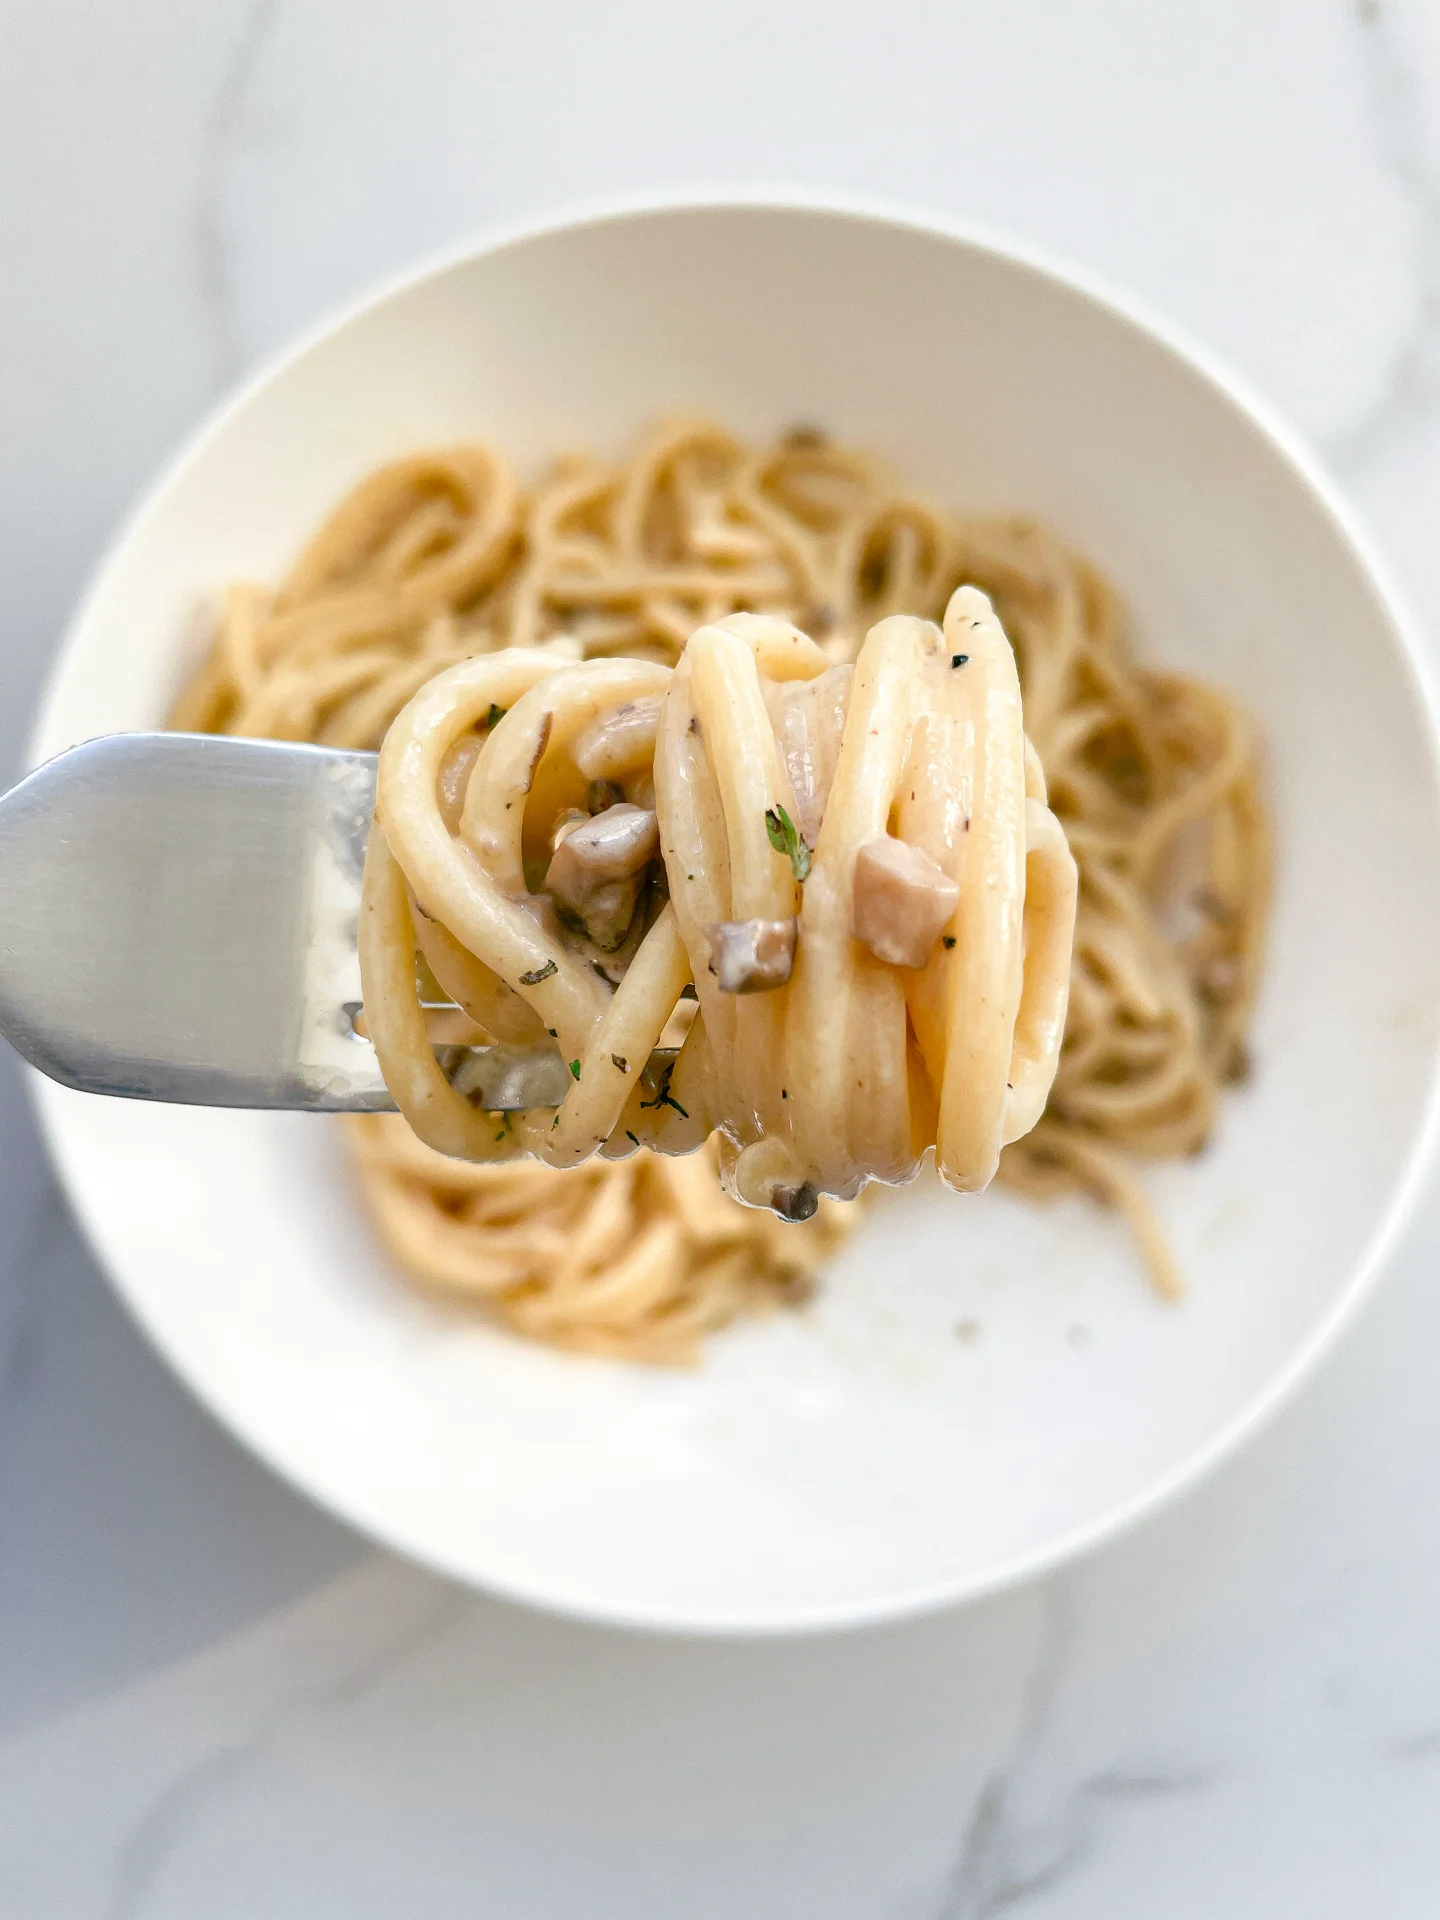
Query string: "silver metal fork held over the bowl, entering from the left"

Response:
xmin=0 ymin=733 xmax=674 ymax=1114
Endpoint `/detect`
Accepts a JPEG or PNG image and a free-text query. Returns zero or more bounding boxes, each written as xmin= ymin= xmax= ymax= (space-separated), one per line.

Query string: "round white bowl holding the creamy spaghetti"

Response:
xmin=36 ymin=204 xmax=1440 ymax=1630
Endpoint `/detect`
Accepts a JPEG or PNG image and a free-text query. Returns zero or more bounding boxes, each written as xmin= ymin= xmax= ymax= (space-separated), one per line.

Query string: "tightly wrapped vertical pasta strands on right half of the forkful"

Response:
xmin=655 ymin=588 xmax=1075 ymax=1212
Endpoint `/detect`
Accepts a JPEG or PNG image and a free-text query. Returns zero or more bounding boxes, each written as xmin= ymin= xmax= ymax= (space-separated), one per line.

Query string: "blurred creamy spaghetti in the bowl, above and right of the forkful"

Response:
xmin=171 ymin=422 xmax=1267 ymax=1351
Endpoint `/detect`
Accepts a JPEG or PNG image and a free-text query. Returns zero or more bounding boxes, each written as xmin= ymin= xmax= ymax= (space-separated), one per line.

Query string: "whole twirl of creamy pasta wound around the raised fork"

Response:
xmin=361 ymin=588 xmax=1075 ymax=1219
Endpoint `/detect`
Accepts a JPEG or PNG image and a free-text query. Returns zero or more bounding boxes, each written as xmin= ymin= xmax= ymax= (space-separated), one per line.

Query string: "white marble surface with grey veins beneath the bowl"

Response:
xmin=0 ymin=0 xmax=1440 ymax=1920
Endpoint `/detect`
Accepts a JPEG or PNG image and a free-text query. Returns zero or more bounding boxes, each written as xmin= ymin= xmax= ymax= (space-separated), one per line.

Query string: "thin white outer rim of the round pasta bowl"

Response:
xmin=25 ymin=186 xmax=1440 ymax=1640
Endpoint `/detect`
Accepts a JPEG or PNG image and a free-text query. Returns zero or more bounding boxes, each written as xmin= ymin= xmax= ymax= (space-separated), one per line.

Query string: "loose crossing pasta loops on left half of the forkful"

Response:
xmin=359 ymin=647 xmax=710 ymax=1167
